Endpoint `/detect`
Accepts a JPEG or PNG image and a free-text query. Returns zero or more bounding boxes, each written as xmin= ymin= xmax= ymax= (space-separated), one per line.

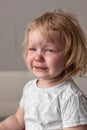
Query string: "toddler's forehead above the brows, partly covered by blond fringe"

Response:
xmin=29 ymin=30 xmax=65 ymax=50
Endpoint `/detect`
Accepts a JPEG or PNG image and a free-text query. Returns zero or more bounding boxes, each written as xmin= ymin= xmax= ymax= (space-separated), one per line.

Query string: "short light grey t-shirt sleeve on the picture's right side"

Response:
xmin=61 ymin=94 xmax=87 ymax=128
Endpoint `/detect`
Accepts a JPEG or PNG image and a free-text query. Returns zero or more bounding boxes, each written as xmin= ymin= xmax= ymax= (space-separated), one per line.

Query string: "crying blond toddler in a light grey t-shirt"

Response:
xmin=0 ymin=9 xmax=87 ymax=130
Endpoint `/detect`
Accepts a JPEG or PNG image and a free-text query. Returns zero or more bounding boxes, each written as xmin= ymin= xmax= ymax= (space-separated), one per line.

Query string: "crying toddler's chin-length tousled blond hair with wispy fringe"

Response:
xmin=23 ymin=9 xmax=87 ymax=79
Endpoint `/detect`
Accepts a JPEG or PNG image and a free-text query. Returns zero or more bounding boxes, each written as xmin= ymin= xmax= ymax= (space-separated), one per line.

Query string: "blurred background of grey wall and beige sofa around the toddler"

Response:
xmin=0 ymin=0 xmax=87 ymax=117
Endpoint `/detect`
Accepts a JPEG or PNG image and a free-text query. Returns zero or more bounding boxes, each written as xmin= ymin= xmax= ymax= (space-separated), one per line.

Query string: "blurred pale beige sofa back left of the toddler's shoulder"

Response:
xmin=0 ymin=71 xmax=35 ymax=117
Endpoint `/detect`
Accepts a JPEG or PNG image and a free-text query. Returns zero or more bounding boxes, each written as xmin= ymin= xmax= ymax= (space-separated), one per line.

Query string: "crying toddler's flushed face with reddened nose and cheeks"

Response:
xmin=26 ymin=30 xmax=64 ymax=80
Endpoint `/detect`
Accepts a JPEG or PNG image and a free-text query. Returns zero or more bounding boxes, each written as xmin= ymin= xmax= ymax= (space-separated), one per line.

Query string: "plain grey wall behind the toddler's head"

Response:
xmin=0 ymin=0 xmax=87 ymax=71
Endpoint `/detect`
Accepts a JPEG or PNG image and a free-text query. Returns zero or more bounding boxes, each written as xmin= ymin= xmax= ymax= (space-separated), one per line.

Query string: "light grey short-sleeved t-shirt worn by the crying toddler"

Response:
xmin=20 ymin=79 xmax=87 ymax=130
